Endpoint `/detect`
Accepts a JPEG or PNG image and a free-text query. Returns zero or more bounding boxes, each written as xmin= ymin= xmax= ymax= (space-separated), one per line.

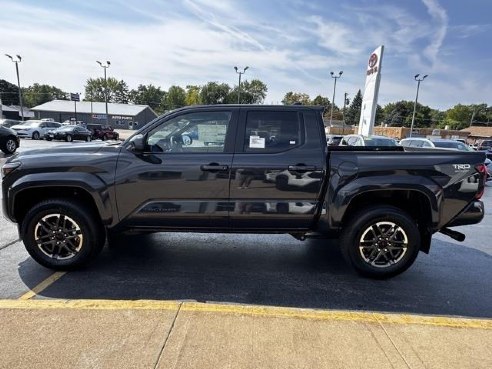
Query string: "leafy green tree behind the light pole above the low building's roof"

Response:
xmin=85 ymin=77 xmax=129 ymax=104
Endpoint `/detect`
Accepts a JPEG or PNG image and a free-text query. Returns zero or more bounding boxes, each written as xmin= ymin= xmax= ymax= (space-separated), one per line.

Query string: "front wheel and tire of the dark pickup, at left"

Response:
xmin=21 ymin=199 xmax=104 ymax=270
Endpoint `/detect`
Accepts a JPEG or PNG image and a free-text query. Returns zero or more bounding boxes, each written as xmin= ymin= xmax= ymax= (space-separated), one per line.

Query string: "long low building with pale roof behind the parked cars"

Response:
xmin=31 ymin=100 xmax=157 ymax=129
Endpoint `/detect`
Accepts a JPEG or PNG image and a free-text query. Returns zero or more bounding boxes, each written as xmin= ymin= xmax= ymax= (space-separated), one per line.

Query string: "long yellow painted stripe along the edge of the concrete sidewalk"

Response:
xmin=0 ymin=299 xmax=492 ymax=330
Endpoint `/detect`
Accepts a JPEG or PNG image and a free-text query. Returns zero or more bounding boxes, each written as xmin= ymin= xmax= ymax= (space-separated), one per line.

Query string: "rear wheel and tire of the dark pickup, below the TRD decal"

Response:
xmin=340 ymin=206 xmax=420 ymax=279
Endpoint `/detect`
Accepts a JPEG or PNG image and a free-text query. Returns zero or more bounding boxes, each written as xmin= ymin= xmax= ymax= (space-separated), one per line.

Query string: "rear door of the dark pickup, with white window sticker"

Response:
xmin=230 ymin=107 xmax=327 ymax=230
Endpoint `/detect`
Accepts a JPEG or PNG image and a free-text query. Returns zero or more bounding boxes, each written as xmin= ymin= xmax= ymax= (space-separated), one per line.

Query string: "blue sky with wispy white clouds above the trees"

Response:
xmin=0 ymin=0 xmax=492 ymax=110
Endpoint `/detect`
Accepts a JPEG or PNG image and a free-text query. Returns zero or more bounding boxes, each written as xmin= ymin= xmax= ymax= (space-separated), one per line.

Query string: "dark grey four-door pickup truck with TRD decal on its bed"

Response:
xmin=2 ymin=105 xmax=485 ymax=278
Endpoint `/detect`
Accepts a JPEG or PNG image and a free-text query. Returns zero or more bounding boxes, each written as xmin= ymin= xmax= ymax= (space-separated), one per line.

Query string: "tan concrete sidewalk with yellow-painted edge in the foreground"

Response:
xmin=0 ymin=300 xmax=492 ymax=369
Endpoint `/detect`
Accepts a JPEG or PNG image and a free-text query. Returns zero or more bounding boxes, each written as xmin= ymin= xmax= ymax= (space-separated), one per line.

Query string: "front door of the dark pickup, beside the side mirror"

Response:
xmin=116 ymin=108 xmax=237 ymax=230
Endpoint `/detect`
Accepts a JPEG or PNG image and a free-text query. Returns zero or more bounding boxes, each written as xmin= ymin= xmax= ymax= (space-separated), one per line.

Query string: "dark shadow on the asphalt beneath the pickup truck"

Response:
xmin=19 ymin=233 xmax=492 ymax=318
